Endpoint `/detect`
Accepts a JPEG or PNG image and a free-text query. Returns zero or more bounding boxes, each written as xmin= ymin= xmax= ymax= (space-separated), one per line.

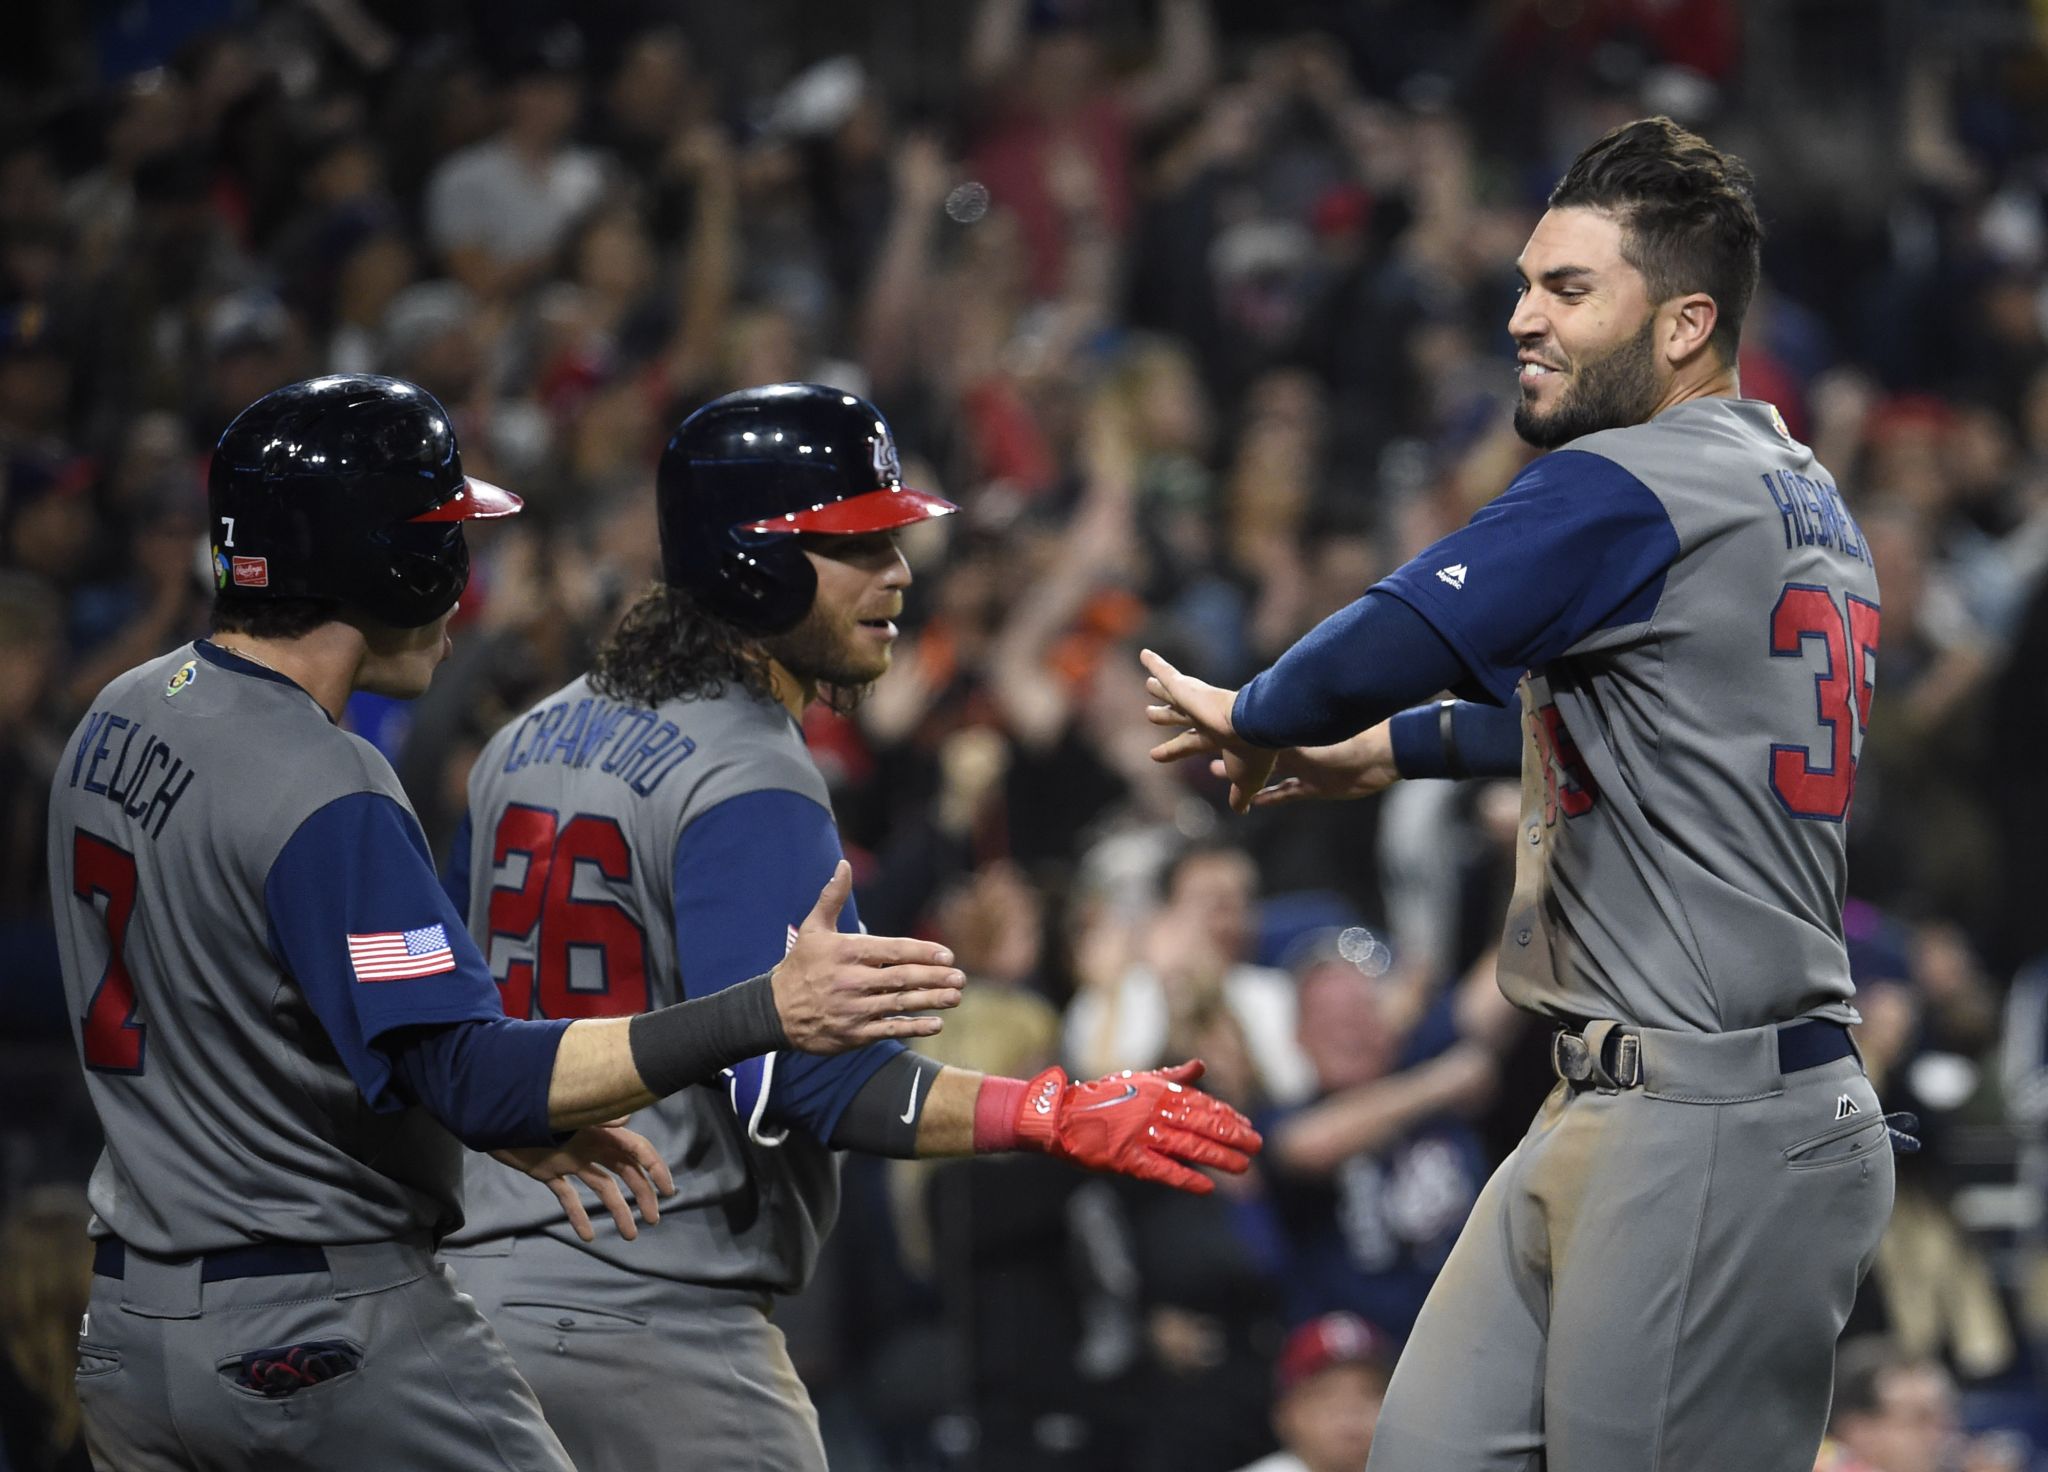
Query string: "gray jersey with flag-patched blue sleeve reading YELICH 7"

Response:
xmin=49 ymin=643 xmax=507 ymax=1257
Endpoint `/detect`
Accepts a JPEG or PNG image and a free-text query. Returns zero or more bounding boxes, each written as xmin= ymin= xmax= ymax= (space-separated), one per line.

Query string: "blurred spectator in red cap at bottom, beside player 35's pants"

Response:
xmin=1243 ymin=1312 xmax=1395 ymax=1472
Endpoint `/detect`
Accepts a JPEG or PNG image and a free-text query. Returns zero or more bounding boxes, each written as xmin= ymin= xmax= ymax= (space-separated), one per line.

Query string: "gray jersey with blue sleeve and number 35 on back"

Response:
xmin=1380 ymin=399 xmax=1878 ymax=1032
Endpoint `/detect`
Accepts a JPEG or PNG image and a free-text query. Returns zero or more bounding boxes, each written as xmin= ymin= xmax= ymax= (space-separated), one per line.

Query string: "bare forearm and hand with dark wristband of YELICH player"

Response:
xmin=547 ymin=860 xmax=965 ymax=1130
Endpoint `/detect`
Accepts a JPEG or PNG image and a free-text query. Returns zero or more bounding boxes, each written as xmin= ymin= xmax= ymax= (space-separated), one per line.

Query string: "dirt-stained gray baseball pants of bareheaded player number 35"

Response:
xmin=1370 ymin=1024 xmax=1892 ymax=1472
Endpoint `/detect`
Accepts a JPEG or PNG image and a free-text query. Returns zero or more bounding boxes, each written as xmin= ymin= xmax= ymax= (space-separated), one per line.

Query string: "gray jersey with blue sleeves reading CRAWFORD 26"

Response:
xmin=449 ymin=680 xmax=897 ymax=1292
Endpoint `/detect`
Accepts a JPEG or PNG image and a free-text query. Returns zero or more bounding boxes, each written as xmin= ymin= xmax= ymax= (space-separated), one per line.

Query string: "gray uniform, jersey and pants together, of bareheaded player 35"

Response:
xmin=1372 ymin=399 xmax=1892 ymax=1472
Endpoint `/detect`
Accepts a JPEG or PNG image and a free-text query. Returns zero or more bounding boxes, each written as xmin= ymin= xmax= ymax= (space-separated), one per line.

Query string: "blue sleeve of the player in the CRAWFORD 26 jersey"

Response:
xmin=676 ymin=788 xmax=903 ymax=1140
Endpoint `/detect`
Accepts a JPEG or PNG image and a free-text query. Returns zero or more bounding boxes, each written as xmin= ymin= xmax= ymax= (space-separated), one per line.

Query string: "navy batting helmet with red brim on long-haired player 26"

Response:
xmin=655 ymin=383 xmax=958 ymax=635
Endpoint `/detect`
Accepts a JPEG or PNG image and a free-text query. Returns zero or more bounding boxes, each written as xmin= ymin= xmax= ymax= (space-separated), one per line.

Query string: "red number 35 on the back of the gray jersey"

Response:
xmin=1772 ymin=583 xmax=1878 ymax=823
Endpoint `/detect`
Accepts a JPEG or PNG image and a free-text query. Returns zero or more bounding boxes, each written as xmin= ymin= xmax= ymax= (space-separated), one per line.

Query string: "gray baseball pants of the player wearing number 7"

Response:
xmin=78 ymin=1243 xmax=573 ymax=1472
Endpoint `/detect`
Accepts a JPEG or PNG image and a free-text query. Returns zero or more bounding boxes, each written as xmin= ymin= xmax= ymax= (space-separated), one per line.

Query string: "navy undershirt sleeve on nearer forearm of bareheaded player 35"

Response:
xmin=1231 ymin=592 xmax=1466 ymax=747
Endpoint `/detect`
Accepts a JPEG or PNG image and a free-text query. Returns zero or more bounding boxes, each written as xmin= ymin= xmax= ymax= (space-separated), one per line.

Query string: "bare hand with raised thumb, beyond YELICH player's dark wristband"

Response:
xmin=770 ymin=858 xmax=967 ymax=1052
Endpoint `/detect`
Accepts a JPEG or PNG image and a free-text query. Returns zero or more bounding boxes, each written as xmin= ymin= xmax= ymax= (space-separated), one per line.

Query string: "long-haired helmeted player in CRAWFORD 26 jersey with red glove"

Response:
xmin=449 ymin=383 xmax=1257 ymax=1472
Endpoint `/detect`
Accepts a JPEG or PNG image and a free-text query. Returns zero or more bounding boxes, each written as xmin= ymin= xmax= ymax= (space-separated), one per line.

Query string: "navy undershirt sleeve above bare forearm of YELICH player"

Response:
xmin=379 ymin=1018 xmax=569 ymax=1151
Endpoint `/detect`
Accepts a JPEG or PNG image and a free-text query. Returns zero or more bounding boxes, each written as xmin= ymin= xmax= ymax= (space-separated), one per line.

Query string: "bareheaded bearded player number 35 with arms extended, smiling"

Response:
xmin=1145 ymin=119 xmax=1892 ymax=1472
